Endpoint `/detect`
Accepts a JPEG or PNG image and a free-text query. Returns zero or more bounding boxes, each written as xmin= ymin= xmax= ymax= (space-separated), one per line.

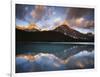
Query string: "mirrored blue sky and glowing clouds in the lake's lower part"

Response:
xmin=16 ymin=51 xmax=94 ymax=72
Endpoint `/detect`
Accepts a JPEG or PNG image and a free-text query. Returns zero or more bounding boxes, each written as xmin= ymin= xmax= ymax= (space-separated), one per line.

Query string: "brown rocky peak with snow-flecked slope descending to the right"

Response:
xmin=55 ymin=25 xmax=94 ymax=41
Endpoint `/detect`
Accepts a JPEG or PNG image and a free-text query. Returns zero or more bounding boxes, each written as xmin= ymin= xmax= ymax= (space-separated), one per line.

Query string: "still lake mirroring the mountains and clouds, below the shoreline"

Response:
xmin=16 ymin=42 xmax=94 ymax=73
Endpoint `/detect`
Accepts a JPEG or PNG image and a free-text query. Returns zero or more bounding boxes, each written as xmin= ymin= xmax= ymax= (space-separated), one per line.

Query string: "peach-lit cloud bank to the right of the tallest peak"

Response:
xmin=68 ymin=17 xmax=94 ymax=29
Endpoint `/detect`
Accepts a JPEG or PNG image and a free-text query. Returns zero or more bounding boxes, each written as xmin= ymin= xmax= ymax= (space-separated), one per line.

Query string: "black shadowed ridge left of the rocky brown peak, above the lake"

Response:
xmin=16 ymin=29 xmax=66 ymax=42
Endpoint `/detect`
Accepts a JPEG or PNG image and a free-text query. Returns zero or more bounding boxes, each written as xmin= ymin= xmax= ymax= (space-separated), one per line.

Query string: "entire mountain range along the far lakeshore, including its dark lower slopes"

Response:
xmin=16 ymin=25 xmax=94 ymax=42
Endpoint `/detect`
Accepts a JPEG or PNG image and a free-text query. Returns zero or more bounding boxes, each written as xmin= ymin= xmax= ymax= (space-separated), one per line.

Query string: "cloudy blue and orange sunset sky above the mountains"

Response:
xmin=16 ymin=4 xmax=94 ymax=33
